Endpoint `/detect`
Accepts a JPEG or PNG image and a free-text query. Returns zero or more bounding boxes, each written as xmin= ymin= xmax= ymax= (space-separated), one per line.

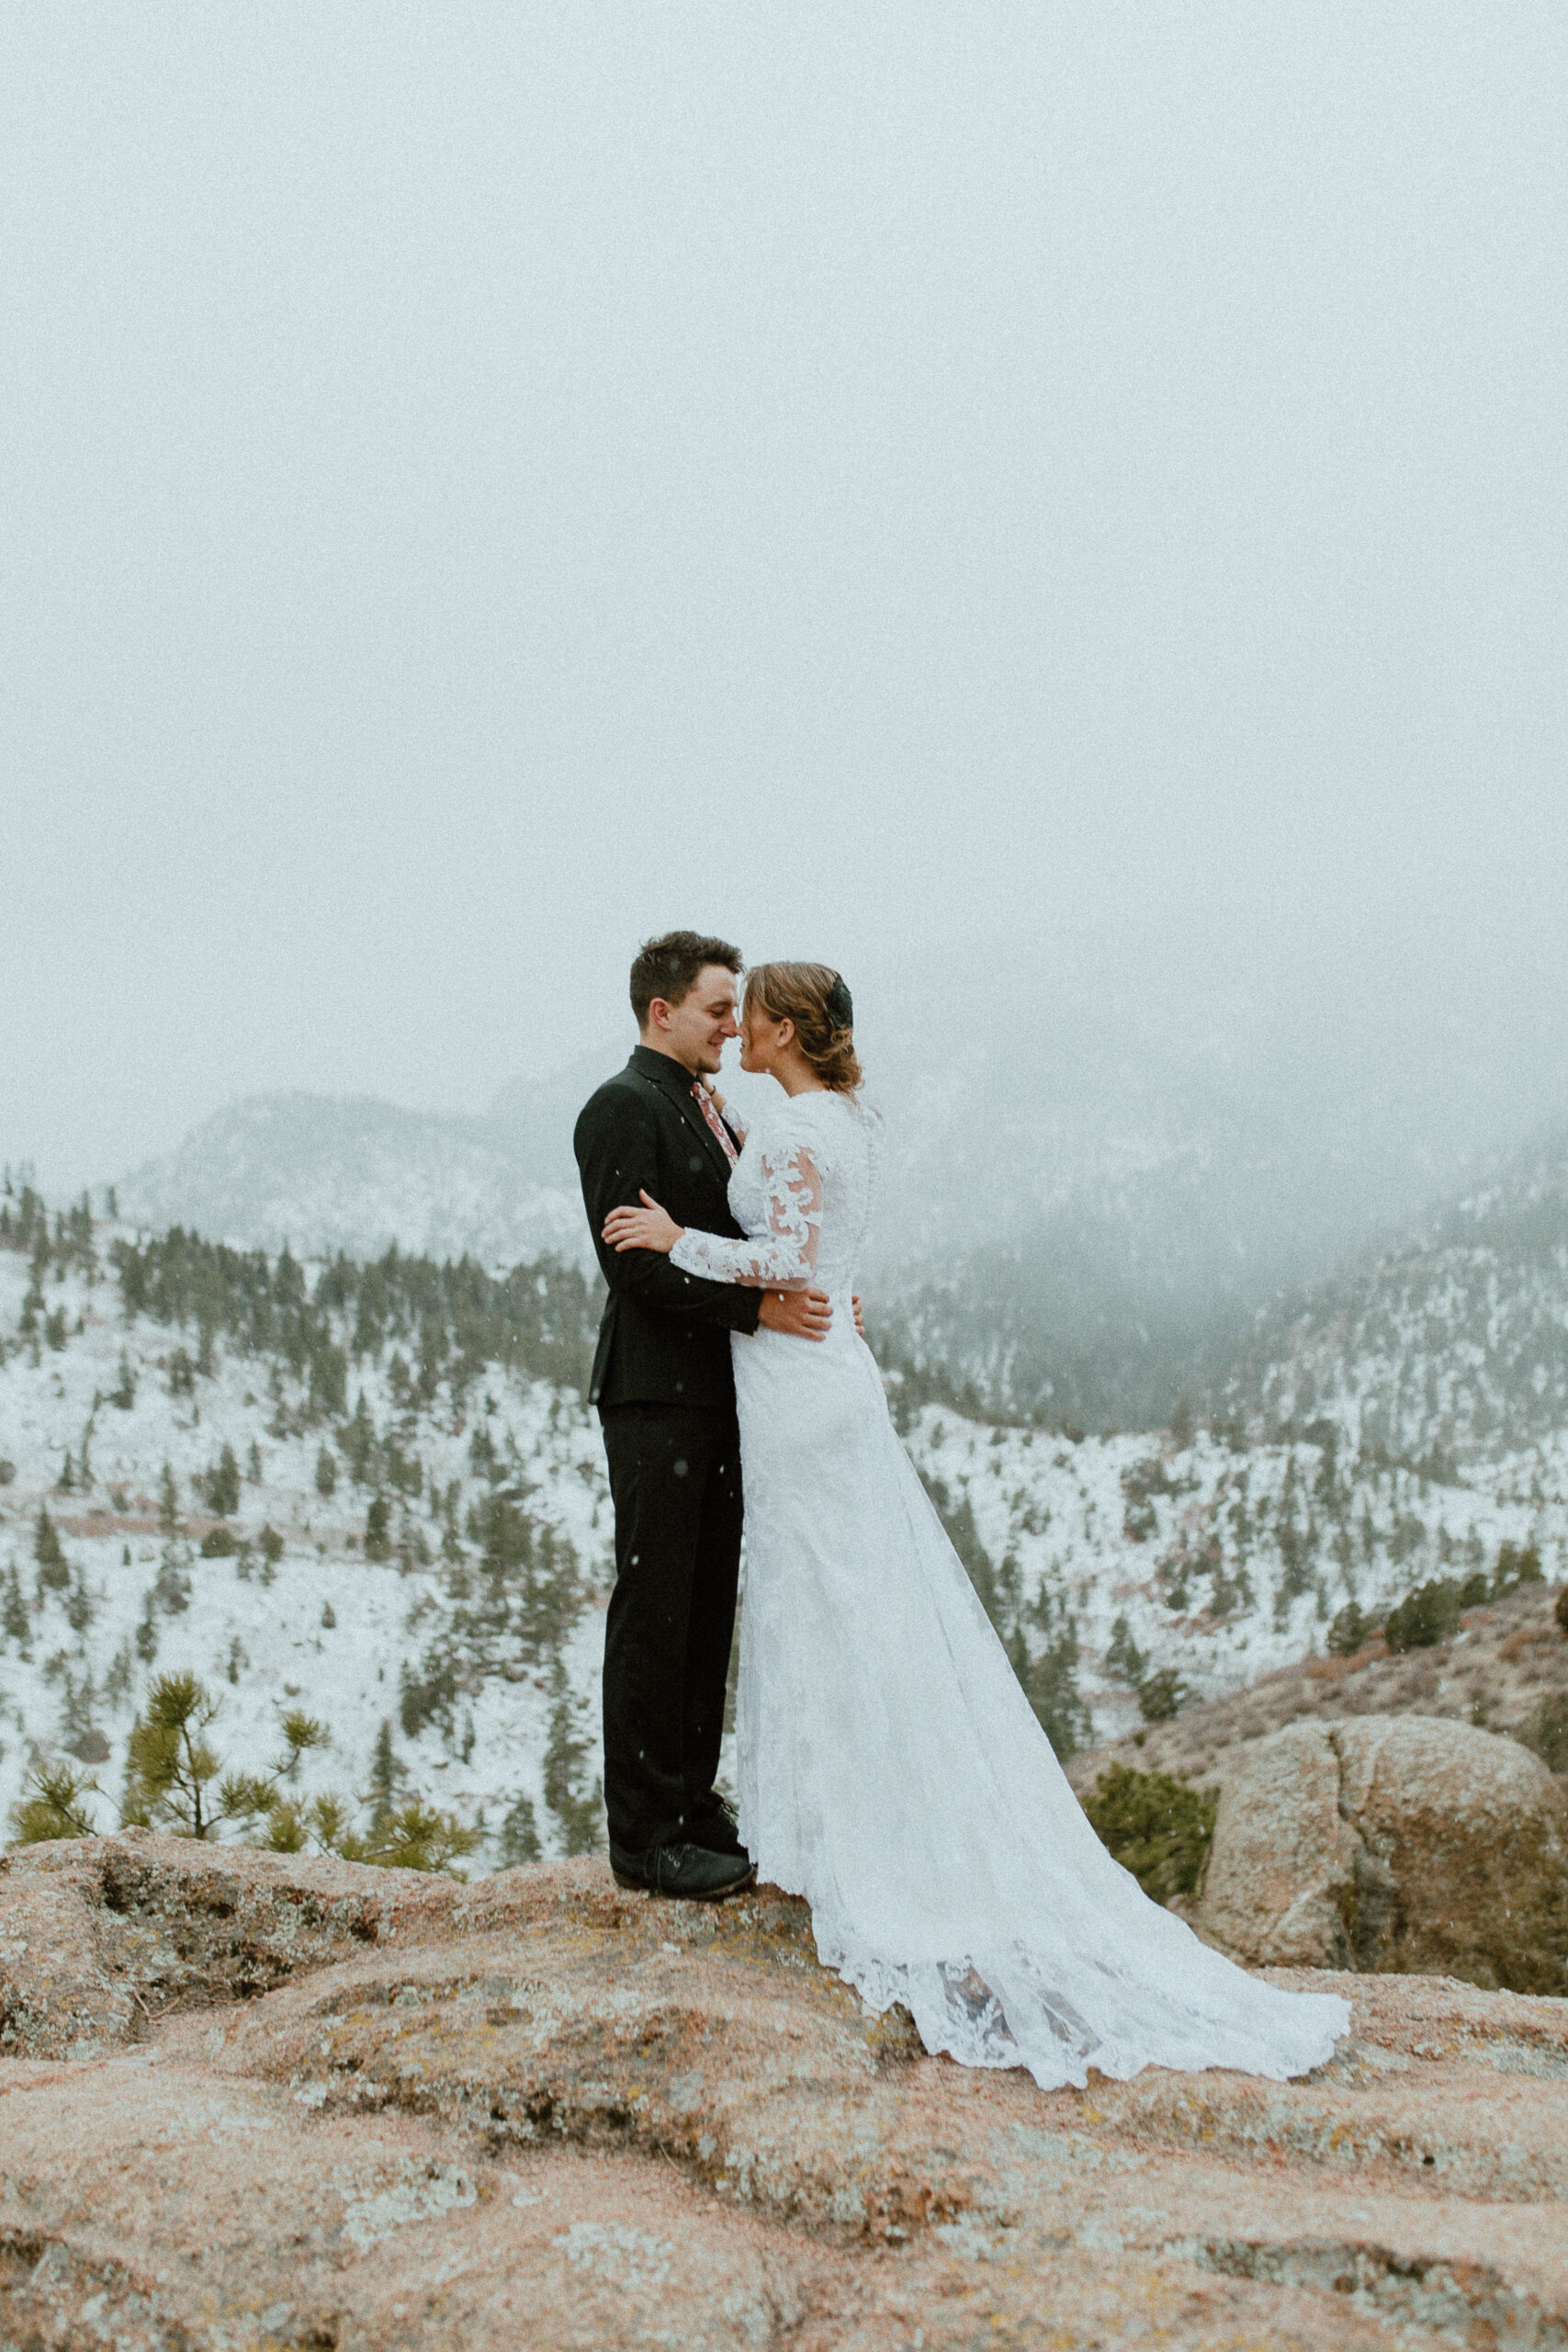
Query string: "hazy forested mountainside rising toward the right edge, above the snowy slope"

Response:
xmin=1211 ymin=1125 xmax=1568 ymax=1461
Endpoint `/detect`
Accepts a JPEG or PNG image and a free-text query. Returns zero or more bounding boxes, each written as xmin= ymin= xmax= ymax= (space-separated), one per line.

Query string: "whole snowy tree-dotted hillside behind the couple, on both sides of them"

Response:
xmin=0 ymin=1218 xmax=1568 ymax=1868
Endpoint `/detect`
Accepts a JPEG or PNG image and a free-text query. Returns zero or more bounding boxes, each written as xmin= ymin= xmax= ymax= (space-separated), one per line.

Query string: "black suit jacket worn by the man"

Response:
xmin=571 ymin=1045 xmax=761 ymax=1408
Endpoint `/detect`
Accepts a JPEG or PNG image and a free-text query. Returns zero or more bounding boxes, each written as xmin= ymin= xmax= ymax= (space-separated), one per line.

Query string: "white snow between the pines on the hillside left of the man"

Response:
xmin=0 ymin=1251 xmax=611 ymax=1847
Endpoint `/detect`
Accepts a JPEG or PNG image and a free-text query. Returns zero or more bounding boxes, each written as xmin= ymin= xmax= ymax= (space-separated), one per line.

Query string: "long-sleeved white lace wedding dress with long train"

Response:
xmin=672 ymin=1093 xmax=1349 ymax=2088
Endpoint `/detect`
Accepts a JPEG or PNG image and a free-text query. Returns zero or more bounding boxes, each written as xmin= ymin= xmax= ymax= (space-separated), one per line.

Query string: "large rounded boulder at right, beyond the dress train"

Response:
xmin=1199 ymin=1714 xmax=1568 ymax=1995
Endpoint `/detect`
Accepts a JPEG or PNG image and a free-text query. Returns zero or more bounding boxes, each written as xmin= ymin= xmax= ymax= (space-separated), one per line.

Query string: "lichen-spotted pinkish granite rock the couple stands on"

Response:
xmin=0 ymin=1837 xmax=1568 ymax=2352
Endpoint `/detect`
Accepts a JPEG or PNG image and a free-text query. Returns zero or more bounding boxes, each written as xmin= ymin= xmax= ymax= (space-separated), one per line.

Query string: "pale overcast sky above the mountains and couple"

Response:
xmin=0 ymin=0 xmax=1568 ymax=1185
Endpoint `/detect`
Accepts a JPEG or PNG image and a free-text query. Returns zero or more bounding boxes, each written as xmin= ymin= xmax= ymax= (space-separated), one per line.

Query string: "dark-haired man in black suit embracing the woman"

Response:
xmin=571 ymin=932 xmax=832 ymax=1898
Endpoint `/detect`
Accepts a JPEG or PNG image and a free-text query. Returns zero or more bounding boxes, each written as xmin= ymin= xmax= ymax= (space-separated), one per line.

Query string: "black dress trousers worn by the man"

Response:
xmin=600 ymin=1402 xmax=740 ymax=1853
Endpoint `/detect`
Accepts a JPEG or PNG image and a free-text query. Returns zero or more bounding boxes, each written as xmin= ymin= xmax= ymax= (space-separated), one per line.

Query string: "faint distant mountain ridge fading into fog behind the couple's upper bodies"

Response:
xmin=120 ymin=1004 xmax=1561 ymax=1430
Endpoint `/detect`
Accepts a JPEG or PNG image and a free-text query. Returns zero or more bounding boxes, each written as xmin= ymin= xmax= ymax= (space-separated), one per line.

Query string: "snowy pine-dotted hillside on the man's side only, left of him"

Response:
xmin=0 ymin=1227 xmax=609 ymax=1865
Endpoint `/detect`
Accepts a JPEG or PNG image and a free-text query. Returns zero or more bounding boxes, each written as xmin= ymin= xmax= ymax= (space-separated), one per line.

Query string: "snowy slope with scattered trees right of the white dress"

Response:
xmin=908 ymin=1407 xmax=1568 ymax=1746
